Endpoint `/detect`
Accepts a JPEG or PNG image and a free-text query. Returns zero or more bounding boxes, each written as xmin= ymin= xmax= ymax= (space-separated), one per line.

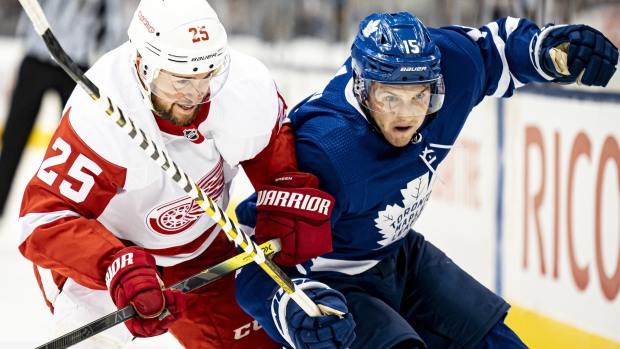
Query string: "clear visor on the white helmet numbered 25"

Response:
xmin=150 ymin=55 xmax=230 ymax=105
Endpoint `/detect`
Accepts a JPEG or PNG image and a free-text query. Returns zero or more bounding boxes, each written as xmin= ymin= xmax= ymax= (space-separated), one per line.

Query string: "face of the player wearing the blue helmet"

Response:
xmin=368 ymin=82 xmax=431 ymax=147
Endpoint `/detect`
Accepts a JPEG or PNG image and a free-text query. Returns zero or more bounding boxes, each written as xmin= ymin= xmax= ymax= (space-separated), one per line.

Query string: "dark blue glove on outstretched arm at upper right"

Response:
xmin=540 ymin=24 xmax=618 ymax=86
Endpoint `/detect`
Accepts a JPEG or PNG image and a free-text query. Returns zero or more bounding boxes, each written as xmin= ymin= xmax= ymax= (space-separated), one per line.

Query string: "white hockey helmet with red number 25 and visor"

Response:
xmin=127 ymin=0 xmax=230 ymax=109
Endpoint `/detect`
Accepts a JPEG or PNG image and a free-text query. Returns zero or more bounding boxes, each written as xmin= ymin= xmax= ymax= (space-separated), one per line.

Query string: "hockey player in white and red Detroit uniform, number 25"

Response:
xmin=19 ymin=0 xmax=333 ymax=349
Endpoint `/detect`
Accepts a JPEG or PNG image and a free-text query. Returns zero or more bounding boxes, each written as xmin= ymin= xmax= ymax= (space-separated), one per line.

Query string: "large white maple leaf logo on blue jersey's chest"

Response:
xmin=375 ymin=172 xmax=435 ymax=247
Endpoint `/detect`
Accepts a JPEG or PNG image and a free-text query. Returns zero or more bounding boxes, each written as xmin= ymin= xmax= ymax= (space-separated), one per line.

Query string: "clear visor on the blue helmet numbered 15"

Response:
xmin=362 ymin=76 xmax=445 ymax=117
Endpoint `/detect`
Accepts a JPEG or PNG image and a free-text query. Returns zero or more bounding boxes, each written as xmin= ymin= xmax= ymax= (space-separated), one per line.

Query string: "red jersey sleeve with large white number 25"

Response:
xmin=19 ymin=109 xmax=126 ymax=289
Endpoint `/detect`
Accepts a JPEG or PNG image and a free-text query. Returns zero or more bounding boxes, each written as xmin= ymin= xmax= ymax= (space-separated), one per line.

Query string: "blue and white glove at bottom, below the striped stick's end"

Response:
xmin=286 ymin=288 xmax=355 ymax=349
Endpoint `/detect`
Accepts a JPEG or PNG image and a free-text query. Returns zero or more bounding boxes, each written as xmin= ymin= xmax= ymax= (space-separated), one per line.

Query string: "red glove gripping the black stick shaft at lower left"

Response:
xmin=106 ymin=247 xmax=186 ymax=337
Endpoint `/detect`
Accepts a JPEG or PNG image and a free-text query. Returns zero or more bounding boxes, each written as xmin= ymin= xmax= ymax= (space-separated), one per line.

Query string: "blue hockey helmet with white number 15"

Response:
xmin=351 ymin=12 xmax=444 ymax=116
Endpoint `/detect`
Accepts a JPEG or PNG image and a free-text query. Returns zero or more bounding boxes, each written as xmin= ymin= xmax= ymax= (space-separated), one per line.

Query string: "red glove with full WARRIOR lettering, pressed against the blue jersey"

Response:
xmin=255 ymin=172 xmax=334 ymax=267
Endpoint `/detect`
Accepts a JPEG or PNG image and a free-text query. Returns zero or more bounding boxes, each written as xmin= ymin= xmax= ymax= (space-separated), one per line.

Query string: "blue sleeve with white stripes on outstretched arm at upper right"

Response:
xmin=438 ymin=17 xmax=548 ymax=97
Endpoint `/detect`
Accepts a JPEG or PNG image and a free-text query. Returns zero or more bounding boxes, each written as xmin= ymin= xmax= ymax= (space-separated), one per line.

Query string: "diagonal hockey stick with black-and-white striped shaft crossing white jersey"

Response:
xmin=19 ymin=0 xmax=323 ymax=317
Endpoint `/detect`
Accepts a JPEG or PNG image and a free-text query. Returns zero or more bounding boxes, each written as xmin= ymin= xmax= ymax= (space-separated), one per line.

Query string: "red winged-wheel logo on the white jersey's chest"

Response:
xmin=146 ymin=157 xmax=224 ymax=235
